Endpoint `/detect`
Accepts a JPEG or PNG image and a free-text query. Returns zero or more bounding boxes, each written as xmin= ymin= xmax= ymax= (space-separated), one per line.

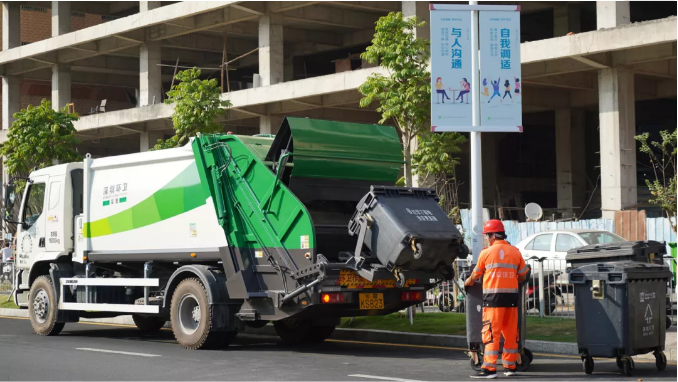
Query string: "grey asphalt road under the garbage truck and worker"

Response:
xmin=0 ymin=317 xmax=676 ymax=382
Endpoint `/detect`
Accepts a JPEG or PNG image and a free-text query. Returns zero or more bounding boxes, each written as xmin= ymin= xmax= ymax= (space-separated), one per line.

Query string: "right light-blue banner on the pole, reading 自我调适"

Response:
xmin=478 ymin=11 xmax=523 ymax=131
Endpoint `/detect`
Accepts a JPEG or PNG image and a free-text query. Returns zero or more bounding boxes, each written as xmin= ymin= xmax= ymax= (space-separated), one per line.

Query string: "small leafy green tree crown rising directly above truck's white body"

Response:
xmin=153 ymin=68 xmax=231 ymax=150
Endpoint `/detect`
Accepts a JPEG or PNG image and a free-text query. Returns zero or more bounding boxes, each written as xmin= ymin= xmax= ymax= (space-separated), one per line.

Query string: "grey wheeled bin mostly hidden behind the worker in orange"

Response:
xmin=457 ymin=257 xmax=534 ymax=371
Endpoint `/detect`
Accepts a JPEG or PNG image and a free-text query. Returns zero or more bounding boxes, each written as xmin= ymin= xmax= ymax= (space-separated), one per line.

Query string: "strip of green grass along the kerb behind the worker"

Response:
xmin=339 ymin=313 xmax=577 ymax=342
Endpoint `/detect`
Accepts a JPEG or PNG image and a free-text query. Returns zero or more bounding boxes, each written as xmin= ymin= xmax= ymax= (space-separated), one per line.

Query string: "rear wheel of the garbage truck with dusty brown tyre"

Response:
xmin=170 ymin=278 xmax=237 ymax=350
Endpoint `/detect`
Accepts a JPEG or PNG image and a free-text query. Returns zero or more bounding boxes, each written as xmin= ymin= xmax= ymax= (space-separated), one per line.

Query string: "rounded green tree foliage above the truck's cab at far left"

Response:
xmin=0 ymin=99 xmax=82 ymax=176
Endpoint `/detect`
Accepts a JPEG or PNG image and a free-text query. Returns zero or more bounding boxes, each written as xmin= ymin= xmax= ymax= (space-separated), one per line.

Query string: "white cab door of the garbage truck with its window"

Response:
xmin=16 ymin=176 xmax=49 ymax=268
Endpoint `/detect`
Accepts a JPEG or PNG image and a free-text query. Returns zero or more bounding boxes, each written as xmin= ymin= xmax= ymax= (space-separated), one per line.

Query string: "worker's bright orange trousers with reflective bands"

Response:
xmin=482 ymin=308 xmax=519 ymax=371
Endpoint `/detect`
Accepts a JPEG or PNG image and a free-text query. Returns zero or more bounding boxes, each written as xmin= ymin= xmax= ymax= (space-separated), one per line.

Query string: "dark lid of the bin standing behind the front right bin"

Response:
xmin=565 ymin=240 xmax=666 ymax=261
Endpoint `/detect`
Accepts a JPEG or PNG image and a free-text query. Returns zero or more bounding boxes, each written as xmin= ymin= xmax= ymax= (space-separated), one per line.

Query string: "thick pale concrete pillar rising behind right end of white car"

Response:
xmin=598 ymin=68 xmax=638 ymax=219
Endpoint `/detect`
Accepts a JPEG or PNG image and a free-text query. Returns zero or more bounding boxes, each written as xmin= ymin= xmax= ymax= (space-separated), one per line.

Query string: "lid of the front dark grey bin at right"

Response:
xmin=570 ymin=261 xmax=673 ymax=280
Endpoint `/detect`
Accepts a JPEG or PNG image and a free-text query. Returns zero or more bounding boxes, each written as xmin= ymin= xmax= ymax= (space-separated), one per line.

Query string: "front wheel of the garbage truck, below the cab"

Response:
xmin=28 ymin=276 xmax=65 ymax=336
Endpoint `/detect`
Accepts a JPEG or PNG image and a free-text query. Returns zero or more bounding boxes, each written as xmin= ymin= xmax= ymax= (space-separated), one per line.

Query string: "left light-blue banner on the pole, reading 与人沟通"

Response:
xmin=431 ymin=11 xmax=473 ymax=126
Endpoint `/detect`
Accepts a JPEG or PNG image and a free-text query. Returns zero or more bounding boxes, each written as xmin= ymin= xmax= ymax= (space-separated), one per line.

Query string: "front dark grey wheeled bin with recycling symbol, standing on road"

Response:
xmin=569 ymin=262 xmax=671 ymax=376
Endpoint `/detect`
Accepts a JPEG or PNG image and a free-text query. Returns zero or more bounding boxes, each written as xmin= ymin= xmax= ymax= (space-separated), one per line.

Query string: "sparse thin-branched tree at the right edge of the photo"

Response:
xmin=636 ymin=129 xmax=677 ymax=232
